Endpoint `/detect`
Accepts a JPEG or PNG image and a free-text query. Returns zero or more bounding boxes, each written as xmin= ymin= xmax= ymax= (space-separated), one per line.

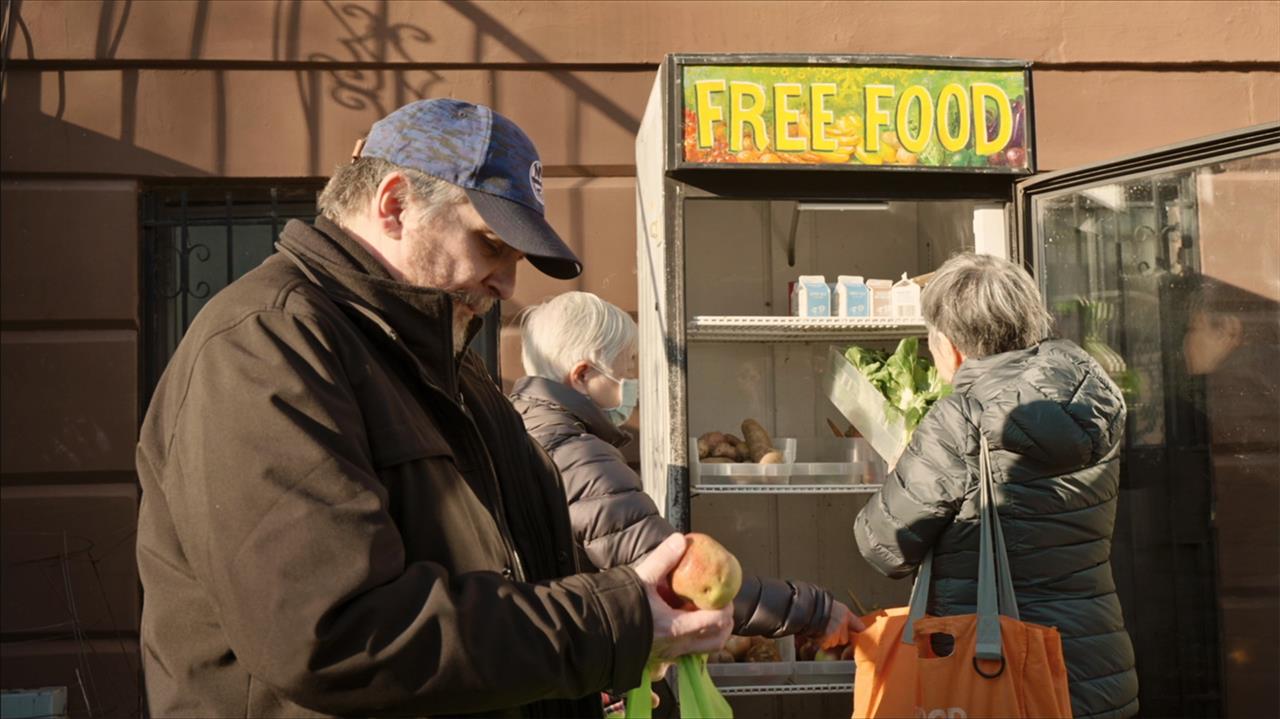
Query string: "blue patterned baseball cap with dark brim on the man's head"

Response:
xmin=360 ymin=99 xmax=582 ymax=279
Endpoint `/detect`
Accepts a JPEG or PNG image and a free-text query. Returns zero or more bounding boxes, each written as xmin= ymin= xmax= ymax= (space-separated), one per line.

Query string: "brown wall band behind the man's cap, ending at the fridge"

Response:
xmin=0 ymin=69 xmax=653 ymax=177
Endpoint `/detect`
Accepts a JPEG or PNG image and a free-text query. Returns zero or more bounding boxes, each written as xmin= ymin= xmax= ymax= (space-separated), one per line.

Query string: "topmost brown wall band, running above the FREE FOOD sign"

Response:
xmin=14 ymin=0 xmax=1280 ymax=63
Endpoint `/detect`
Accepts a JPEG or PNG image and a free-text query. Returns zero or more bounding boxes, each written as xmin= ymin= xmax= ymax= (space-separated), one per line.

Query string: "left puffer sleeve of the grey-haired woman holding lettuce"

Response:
xmin=854 ymin=395 xmax=977 ymax=578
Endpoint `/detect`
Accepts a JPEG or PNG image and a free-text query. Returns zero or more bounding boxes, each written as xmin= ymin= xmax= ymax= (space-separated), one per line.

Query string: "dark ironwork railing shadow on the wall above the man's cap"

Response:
xmin=4 ymin=0 xmax=640 ymax=177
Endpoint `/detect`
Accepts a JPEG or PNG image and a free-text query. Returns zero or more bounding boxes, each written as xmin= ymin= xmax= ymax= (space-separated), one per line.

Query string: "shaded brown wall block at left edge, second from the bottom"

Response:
xmin=0 ymin=484 xmax=141 ymax=635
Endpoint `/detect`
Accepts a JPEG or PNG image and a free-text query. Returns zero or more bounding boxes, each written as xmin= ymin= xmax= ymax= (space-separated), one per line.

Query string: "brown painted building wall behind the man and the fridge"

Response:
xmin=0 ymin=0 xmax=1280 ymax=715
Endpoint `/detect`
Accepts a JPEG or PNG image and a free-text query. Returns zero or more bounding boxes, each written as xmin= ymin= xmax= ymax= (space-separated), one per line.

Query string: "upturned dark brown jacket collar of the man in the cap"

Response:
xmin=279 ymin=216 xmax=481 ymax=386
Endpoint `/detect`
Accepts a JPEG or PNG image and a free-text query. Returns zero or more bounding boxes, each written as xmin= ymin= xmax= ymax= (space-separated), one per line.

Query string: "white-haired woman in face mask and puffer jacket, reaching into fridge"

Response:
xmin=511 ymin=292 xmax=861 ymax=637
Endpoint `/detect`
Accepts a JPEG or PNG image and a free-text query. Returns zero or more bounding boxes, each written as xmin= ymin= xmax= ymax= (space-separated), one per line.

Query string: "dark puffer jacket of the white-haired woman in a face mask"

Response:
xmin=511 ymin=377 xmax=832 ymax=637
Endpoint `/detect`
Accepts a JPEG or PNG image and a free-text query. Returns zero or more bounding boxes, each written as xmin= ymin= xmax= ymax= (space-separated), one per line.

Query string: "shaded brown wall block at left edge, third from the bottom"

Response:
xmin=0 ymin=330 xmax=138 ymax=475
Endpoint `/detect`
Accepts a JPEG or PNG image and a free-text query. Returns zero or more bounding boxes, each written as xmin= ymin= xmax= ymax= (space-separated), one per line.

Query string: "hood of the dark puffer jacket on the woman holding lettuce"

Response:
xmin=954 ymin=340 xmax=1125 ymax=472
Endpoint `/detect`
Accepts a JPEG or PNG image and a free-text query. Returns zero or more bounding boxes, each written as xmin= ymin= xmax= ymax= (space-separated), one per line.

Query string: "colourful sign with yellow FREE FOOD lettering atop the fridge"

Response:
xmin=681 ymin=65 xmax=1030 ymax=173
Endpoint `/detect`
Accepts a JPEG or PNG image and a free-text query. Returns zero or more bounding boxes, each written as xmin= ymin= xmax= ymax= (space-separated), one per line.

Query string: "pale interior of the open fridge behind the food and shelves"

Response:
xmin=684 ymin=198 xmax=1007 ymax=715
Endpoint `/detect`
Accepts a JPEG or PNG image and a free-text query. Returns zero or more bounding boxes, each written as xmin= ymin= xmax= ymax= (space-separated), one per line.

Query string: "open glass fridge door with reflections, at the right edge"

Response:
xmin=1016 ymin=125 xmax=1280 ymax=716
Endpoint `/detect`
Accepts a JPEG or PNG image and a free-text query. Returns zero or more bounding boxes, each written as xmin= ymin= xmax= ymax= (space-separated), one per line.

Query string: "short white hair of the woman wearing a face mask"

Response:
xmin=520 ymin=292 xmax=636 ymax=383
